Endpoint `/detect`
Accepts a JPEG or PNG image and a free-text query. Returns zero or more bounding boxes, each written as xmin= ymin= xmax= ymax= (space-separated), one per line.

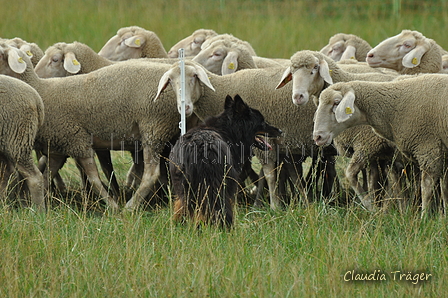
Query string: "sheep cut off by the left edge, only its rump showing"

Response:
xmin=0 ymin=73 xmax=45 ymax=210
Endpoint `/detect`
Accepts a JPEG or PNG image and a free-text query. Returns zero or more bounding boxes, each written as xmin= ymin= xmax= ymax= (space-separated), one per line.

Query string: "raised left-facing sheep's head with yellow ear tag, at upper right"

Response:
xmin=366 ymin=30 xmax=430 ymax=71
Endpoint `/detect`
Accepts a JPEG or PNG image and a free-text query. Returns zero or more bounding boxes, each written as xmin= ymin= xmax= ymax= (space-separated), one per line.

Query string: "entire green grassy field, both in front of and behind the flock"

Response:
xmin=0 ymin=0 xmax=448 ymax=298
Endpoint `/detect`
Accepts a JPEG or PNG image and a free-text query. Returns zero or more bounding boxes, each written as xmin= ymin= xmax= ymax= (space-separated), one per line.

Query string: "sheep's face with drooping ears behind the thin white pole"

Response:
xmin=155 ymin=63 xmax=215 ymax=117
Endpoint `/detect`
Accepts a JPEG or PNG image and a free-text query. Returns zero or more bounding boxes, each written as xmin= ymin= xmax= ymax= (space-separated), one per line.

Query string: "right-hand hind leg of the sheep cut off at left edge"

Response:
xmin=16 ymin=158 xmax=45 ymax=211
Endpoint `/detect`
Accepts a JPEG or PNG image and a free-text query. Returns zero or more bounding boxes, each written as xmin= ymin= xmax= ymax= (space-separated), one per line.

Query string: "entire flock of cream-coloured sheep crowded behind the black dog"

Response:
xmin=0 ymin=26 xmax=448 ymax=217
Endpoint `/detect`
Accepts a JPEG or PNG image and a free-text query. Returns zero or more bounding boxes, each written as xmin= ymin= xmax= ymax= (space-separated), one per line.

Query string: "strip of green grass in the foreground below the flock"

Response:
xmin=0 ymin=204 xmax=448 ymax=297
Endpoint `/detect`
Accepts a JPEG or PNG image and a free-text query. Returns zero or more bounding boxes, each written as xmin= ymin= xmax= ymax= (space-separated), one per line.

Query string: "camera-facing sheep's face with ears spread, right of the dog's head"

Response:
xmin=277 ymin=51 xmax=333 ymax=105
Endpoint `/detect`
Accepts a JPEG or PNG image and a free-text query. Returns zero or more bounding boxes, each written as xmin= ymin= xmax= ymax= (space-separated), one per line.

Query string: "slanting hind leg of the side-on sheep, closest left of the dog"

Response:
xmin=125 ymin=150 xmax=160 ymax=211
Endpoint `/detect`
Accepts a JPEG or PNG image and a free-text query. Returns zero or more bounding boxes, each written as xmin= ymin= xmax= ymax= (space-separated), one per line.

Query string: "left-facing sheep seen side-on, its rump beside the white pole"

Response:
xmin=0 ymin=43 xmax=200 ymax=210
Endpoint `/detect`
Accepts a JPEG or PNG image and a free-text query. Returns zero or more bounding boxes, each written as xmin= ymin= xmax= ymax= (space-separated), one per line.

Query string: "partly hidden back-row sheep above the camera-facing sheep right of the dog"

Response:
xmin=320 ymin=33 xmax=372 ymax=62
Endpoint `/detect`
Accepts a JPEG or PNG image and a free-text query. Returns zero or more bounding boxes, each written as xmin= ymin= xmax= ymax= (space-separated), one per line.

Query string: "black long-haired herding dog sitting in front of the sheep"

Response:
xmin=170 ymin=95 xmax=281 ymax=227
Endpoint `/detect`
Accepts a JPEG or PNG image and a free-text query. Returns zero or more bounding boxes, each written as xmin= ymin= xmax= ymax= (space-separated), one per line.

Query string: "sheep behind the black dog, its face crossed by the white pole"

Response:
xmin=157 ymin=61 xmax=335 ymax=209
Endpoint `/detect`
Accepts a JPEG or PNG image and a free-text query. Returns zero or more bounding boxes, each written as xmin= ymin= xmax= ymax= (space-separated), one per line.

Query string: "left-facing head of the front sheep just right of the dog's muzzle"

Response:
xmin=313 ymin=84 xmax=357 ymax=146
